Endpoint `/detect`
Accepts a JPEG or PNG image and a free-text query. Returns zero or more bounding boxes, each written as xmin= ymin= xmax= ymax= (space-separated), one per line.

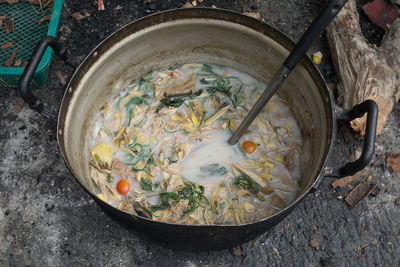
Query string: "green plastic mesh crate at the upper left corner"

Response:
xmin=0 ymin=0 xmax=63 ymax=88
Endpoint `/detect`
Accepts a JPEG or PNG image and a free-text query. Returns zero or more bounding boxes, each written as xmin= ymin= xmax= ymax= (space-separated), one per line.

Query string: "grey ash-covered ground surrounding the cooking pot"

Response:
xmin=0 ymin=0 xmax=400 ymax=266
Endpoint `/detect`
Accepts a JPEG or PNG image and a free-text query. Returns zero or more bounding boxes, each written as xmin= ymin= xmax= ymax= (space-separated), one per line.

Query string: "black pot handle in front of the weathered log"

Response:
xmin=337 ymin=99 xmax=378 ymax=177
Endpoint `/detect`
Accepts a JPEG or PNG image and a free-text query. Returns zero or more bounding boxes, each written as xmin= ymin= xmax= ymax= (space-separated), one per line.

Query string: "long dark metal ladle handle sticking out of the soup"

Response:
xmin=228 ymin=0 xmax=347 ymax=145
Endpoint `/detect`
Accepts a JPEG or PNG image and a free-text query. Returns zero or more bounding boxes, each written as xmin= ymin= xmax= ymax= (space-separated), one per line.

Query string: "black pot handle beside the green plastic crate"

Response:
xmin=19 ymin=36 xmax=66 ymax=113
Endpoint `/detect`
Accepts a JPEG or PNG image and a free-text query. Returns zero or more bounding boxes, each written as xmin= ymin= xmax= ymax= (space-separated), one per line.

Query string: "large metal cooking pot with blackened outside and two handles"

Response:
xmin=20 ymin=8 xmax=377 ymax=250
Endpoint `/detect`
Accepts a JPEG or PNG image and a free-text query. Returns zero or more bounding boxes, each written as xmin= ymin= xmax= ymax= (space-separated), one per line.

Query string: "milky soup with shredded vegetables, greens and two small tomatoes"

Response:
xmin=89 ymin=64 xmax=302 ymax=225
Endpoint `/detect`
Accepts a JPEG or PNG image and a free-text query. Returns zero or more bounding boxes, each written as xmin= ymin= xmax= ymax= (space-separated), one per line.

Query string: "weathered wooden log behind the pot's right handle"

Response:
xmin=326 ymin=0 xmax=400 ymax=136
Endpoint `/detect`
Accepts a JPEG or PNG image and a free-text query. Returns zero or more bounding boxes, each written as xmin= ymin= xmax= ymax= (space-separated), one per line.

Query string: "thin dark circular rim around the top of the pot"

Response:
xmin=57 ymin=7 xmax=336 ymax=228
